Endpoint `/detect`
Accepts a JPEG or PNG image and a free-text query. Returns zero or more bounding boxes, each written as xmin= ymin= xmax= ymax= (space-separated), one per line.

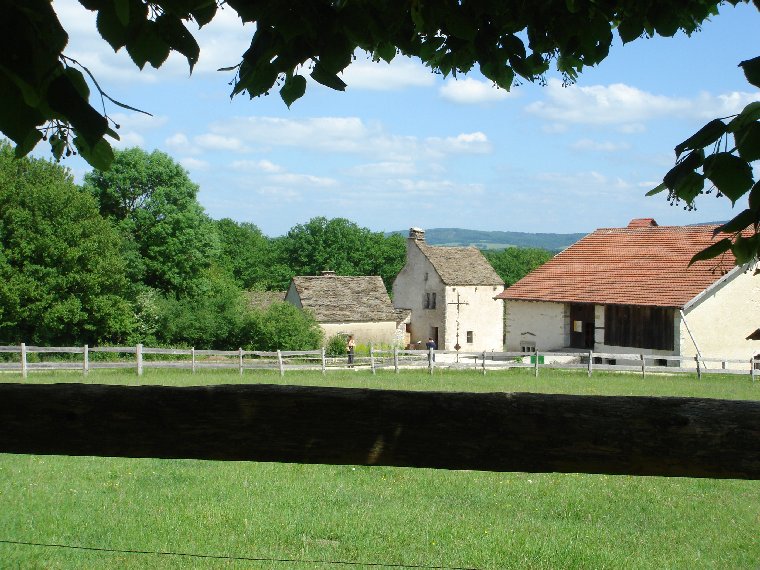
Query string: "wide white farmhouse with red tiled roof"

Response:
xmin=499 ymin=218 xmax=760 ymax=359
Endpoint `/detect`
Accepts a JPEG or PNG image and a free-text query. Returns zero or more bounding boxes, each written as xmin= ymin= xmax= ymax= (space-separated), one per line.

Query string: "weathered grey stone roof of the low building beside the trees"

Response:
xmin=291 ymin=275 xmax=396 ymax=323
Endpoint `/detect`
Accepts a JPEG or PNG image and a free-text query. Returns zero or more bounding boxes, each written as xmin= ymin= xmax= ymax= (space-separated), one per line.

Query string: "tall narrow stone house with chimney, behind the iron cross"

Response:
xmin=393 ymin=228 xmax=504 ymax=351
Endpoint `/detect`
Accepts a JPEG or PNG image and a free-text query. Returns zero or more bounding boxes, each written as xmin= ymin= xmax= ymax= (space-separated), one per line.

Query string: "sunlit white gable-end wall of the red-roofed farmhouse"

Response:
xmin=676 ymin=270 xmax=760 ymax=360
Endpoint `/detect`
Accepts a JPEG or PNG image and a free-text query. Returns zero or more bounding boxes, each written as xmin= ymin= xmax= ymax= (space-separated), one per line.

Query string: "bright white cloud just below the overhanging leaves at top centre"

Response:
xmin=341 ymin=57 xmax=435 ymax=91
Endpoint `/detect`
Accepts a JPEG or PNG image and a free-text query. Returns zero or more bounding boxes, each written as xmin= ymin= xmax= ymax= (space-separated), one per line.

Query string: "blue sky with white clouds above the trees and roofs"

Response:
xmin=43 ymin=0 xmax=760 ymax=236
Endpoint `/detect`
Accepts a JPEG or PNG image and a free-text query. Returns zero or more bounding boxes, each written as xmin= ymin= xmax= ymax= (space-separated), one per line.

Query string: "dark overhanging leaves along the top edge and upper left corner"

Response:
xmin=0 ymin=0 xmax=758 ymax=168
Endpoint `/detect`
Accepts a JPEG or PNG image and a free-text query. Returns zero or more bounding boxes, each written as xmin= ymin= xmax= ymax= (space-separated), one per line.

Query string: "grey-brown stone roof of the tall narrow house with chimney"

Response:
xmin=417 ymin=242 xmax=504 ymax=285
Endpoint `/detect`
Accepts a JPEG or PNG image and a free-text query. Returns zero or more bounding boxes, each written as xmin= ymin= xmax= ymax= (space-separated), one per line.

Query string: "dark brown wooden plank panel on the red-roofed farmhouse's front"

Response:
xmin=604 ymin=305 xmax=674 ymax=350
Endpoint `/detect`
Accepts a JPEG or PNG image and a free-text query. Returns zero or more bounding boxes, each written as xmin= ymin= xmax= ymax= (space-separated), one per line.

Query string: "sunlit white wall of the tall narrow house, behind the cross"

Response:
xmin=438 ymin=285 xmax=504 ymax=352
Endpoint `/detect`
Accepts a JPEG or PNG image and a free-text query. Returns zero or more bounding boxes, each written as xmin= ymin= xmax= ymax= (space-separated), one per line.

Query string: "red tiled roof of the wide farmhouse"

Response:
xmin=497 ymin=219 xmax=734 ymax=307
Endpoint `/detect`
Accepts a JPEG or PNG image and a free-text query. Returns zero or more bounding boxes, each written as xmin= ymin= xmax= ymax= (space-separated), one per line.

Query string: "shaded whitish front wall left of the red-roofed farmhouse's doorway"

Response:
xmin=505 ymin=300 xmax=570 ymax=352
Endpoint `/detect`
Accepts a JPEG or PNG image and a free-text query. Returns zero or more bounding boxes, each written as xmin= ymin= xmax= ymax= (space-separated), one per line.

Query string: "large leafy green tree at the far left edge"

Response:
xmin=0 ymin=141 xmax=133 ymax=345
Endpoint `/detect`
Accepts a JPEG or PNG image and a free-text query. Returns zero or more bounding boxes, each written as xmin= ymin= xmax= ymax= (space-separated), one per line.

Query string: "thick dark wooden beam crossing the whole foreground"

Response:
xmin=0 ymin=384 xmax=760 ymax=479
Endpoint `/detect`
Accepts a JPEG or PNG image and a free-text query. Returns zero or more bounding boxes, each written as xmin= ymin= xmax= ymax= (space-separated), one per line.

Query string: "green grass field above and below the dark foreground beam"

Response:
xmin=0 ymin=370 xmax=760 ymax=569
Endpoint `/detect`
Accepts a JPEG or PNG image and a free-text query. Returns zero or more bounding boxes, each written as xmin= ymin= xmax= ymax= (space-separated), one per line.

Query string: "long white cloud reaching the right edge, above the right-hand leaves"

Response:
xmin=526 ymin=79 xmax=760 ymax=125
